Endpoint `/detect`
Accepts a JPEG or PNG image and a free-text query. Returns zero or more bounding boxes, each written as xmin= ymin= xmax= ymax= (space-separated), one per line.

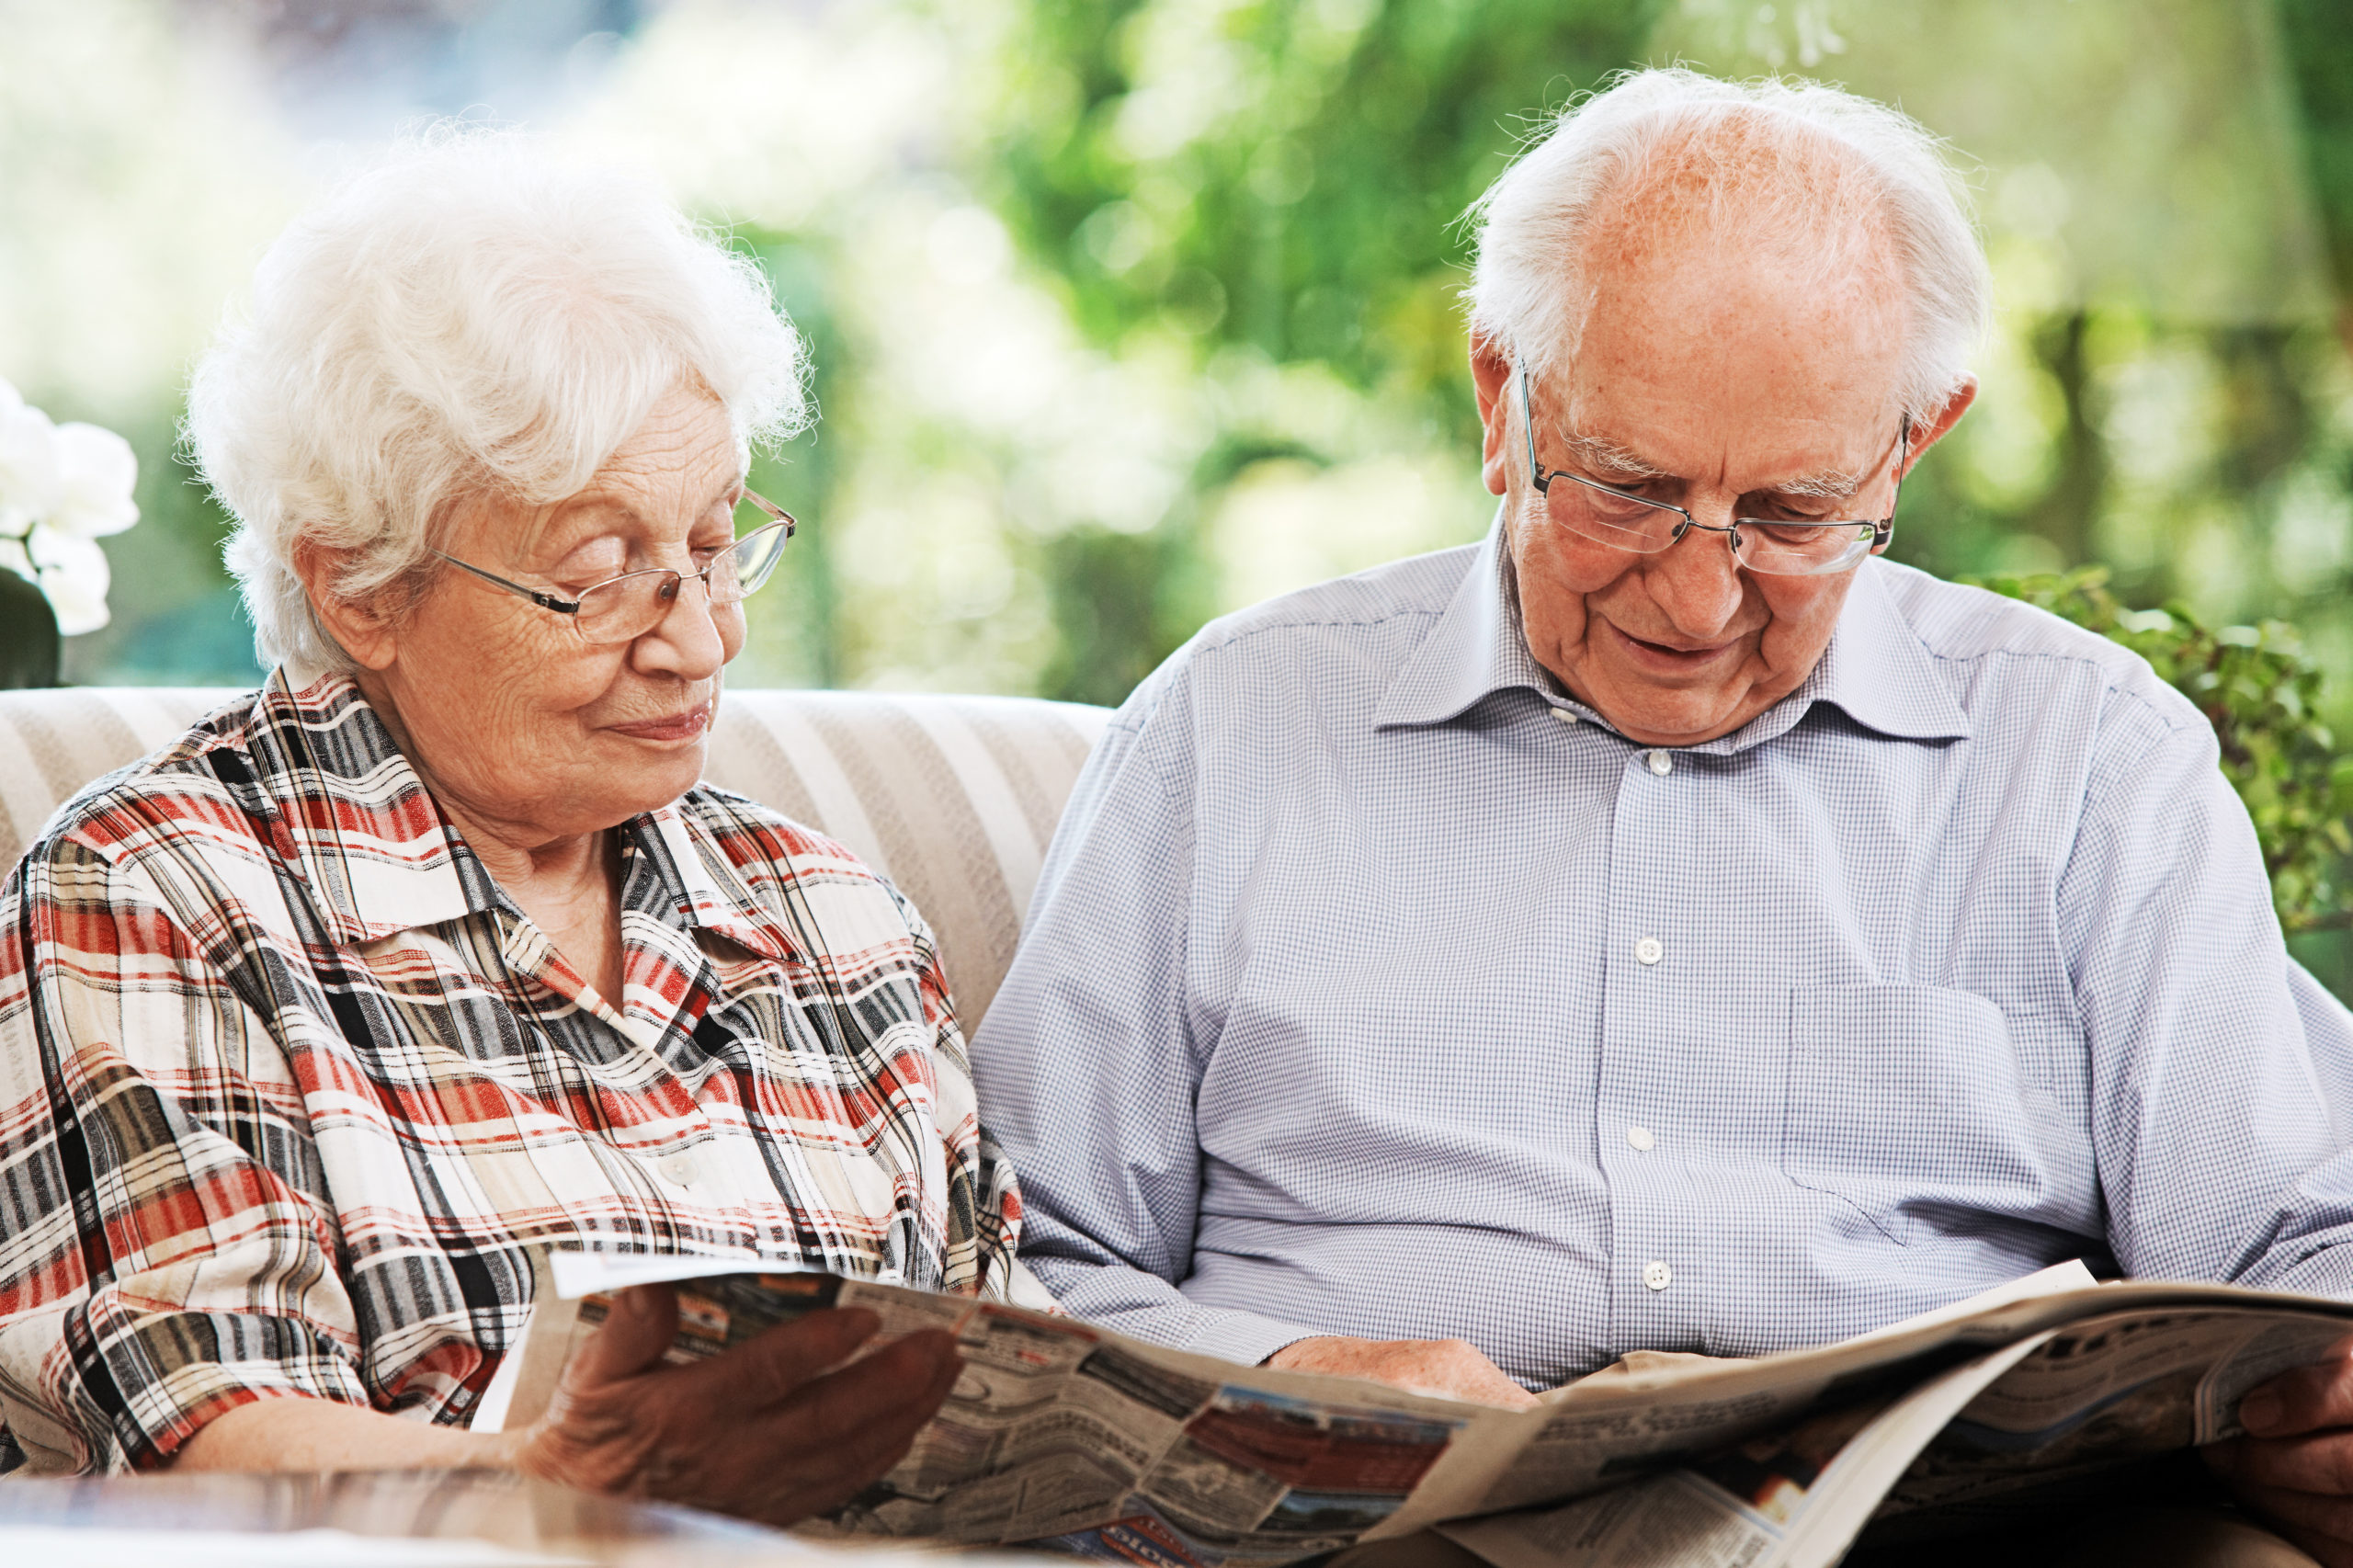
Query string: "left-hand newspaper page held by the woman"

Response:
xmin=511 ymin=1253 xmax=1516 ymax=1568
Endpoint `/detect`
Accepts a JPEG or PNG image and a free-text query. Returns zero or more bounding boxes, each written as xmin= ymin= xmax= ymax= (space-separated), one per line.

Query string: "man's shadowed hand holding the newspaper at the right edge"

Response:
xmin=2205 ymin=1340 xmax=2353 ymax=1568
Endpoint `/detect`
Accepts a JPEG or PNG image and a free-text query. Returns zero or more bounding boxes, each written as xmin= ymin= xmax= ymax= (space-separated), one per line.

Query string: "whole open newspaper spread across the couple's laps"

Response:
xmin=508 ymin=1253 xmax=2353 ymax=1568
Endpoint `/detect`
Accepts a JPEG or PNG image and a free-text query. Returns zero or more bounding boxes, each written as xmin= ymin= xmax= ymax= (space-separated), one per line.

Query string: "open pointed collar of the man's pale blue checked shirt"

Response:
xmin=1371 ymin=508 xmax=1970 ymax=751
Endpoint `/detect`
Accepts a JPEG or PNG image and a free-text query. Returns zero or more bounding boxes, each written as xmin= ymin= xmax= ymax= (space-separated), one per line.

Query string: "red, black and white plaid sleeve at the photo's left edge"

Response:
xmin=0 ymin=835 xmax=369 ymax=1471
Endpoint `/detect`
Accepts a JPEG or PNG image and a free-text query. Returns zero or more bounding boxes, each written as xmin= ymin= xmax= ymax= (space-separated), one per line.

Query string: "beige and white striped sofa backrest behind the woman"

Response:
xmin=0 ymin=687 xmax=1108 ymax=1034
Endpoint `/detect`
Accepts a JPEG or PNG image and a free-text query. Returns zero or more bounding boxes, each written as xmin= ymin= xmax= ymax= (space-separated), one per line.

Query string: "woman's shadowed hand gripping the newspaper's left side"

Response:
xmin=516 ymin=1286 xmax=962 ymax=1523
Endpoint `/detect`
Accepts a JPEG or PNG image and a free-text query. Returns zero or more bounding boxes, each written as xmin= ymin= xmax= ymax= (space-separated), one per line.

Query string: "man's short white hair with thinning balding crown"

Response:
xmin=1466 ymin=68 xmax=1991 ymax=422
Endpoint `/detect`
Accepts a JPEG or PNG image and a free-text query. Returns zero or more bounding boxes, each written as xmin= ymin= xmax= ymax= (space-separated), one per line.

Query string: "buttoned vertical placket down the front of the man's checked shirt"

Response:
xmin=1593 ymin=746 xmax=1706 ymax=1349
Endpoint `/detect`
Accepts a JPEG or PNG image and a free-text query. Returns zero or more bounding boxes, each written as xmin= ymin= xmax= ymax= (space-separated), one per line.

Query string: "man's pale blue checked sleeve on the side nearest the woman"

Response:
xmin=974 ymin=680 xmax=1320 ymax=1363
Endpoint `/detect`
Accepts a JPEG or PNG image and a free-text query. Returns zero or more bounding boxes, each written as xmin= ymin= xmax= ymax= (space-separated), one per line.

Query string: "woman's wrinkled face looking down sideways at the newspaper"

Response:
xmin=350 ymin=389 xmax=744 ymax=846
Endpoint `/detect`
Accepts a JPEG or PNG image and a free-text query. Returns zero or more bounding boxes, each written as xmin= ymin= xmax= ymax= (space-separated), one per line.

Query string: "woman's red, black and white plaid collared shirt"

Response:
xmin=0 ymin=676 xmax=1021 ymax=1469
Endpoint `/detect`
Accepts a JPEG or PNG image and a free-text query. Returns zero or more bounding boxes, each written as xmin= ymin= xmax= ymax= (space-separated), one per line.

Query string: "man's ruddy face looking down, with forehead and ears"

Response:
xmin=1473 ymin=244 xmax=1974 ymax=746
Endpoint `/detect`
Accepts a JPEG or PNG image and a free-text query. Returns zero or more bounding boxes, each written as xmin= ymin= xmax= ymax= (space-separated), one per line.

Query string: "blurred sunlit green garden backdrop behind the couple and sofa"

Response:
xmin=0 ymin=0 xmax=2353 ymax=991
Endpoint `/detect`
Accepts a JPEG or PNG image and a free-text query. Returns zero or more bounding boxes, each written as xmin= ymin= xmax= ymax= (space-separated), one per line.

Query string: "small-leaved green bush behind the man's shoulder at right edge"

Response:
xmin=1982 ymin=567 xmax=2353 ymax=932
